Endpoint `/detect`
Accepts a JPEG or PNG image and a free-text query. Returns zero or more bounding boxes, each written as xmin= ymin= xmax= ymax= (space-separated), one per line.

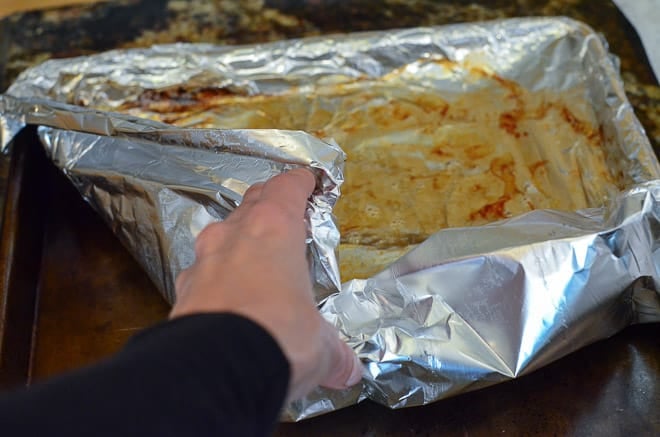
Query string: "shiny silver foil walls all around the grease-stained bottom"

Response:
xmin=0 ymin=18 xmax=660 ymax=421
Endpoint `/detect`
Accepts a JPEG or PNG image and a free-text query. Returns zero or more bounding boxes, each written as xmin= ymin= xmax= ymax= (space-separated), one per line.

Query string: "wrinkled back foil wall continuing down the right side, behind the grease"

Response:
xmin=5 ymin=18 xmax=660 ymax=183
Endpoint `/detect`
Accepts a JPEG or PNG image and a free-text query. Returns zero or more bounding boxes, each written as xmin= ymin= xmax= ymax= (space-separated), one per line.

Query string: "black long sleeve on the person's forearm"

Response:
xmin=0 ymin=314 xmax=289 ymax=437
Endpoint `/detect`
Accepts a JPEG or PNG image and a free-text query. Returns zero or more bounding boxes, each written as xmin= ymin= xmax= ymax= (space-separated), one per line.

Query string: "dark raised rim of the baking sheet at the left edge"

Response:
xmin=0 ymin=127 xmax=52 ymax=389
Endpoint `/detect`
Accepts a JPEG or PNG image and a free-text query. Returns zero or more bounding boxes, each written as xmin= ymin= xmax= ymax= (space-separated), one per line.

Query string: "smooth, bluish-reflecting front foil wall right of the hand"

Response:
xmin=285 ymin=180 xmax=660 ymax=420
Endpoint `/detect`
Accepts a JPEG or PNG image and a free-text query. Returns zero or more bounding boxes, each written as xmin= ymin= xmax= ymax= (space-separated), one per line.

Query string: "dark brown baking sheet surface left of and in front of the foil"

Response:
xmin=0 ymin=130 xmax=660 ymax=437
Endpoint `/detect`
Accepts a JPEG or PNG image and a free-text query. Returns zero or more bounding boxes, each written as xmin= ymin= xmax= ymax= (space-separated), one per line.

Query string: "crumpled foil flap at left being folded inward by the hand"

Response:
xmin=0 ymin=96 xmax=345 ymax=303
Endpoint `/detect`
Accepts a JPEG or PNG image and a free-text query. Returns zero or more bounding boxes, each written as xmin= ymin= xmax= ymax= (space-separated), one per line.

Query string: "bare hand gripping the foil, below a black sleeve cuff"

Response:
xmin=170 ymin=169 xmax=362 ymax=400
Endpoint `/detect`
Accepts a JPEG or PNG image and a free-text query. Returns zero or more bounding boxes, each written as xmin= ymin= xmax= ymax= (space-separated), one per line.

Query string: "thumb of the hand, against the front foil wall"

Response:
xmin=320 ymin=320 xmax=362 ymax=390
